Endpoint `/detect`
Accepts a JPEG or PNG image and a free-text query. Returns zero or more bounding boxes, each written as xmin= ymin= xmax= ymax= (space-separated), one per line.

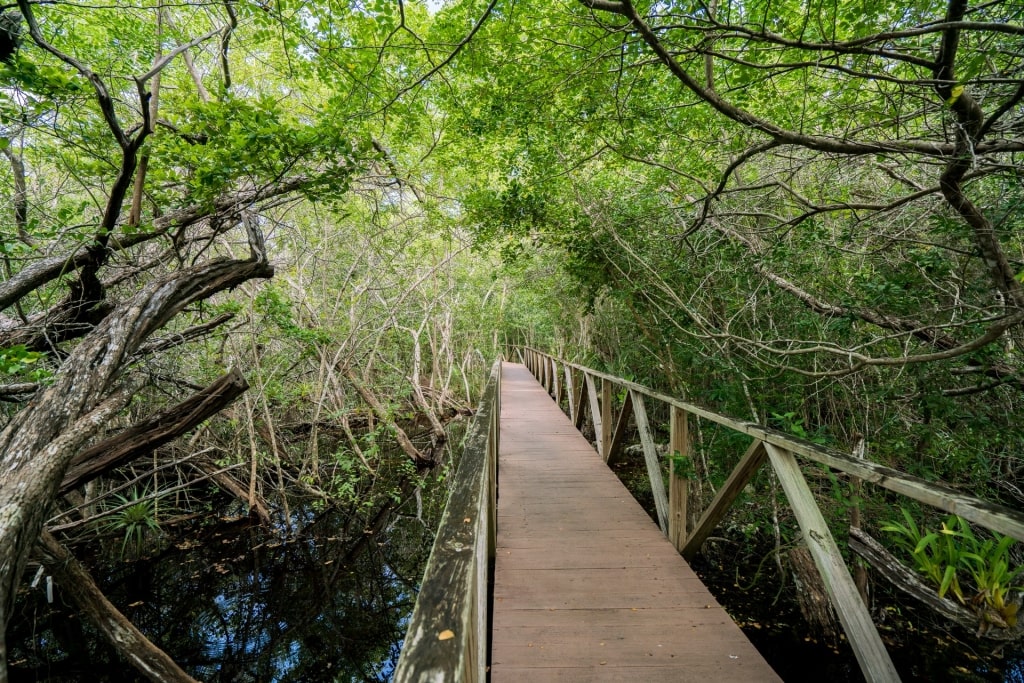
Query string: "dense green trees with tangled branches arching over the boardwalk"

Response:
xmin=0 ymin=0 xmax=1024 ymax=680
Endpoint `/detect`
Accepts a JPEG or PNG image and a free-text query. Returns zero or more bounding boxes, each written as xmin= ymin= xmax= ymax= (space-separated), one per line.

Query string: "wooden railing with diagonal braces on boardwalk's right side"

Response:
xmin=516 ymin=348 xmax=1024 ymax=681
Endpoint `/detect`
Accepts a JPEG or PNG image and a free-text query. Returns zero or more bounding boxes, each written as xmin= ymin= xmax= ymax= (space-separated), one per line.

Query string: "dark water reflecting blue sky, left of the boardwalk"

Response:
xmin=8 ymin=497 xmax=440 ymax=683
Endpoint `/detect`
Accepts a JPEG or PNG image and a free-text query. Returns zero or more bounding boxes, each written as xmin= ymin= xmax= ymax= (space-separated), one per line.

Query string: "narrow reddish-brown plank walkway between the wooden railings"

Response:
xmin=492 ymin=364 xmax=779 ymax=683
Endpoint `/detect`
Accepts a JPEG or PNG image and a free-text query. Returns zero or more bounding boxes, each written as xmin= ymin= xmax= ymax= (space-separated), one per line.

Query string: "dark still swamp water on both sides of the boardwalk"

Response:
xmin=7 ymin=438 xmax=1024 ymax=683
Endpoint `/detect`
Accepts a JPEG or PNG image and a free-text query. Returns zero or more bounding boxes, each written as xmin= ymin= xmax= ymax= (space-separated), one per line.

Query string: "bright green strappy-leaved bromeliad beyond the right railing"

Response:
xmin=882 ymin=508 xmax=1024 ymax=629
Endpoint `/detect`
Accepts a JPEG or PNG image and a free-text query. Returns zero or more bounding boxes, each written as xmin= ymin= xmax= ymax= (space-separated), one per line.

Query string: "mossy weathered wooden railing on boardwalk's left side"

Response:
xmin=393 ymin=360 xmax=502 ymax=683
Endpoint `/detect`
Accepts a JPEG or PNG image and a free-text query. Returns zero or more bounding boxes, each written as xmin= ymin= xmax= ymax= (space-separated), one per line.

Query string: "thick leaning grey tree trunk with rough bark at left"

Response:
xmin=0 ymin=245 xmax=273 ymax=683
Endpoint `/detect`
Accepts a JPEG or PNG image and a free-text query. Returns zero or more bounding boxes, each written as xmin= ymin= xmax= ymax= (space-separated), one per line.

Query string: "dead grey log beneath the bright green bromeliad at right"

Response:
xmin=850 ymin=528 xmax=1024 ymax=641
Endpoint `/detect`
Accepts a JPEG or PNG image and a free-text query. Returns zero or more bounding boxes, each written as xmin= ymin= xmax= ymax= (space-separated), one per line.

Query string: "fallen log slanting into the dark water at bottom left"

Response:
xmin=39 ymin=531 xmax=197 ymax=683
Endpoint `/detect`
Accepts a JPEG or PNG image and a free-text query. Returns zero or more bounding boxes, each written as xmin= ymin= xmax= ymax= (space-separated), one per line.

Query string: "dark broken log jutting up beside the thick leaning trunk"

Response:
xmin=60 ymin=368 xmax=249 ymax=494
